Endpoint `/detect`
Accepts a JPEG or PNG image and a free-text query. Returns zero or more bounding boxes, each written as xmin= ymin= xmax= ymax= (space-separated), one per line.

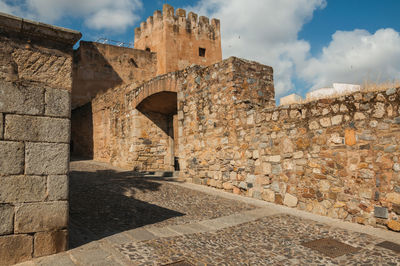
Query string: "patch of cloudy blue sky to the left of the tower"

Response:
xmin=0 ymin=0 xmax=142 ymax=32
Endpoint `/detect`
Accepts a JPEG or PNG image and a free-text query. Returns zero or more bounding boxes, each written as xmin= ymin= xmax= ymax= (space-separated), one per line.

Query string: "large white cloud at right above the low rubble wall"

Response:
xmin=298 ymin=29 xmax=400 ymax=89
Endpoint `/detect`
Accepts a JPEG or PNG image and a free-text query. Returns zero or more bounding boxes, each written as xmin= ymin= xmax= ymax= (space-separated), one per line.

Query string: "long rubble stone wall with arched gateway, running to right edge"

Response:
xmin=83 ymin=4 xmax=400 ymax=231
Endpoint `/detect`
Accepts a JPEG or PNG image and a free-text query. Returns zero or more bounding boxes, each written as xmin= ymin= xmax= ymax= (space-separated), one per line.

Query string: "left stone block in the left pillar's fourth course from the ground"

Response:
xmin=0 ymin=141 xmax=24 ymax=175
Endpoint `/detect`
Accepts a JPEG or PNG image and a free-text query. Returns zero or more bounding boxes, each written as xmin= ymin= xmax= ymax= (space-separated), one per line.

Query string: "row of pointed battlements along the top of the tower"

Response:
xmin=135 ymin=4 xmax=220 ymax=42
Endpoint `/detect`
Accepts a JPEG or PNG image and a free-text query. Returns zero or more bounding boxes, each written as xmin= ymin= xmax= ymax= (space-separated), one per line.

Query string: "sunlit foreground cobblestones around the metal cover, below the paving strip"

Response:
xmin=118 ymin=215 xmax=400 ymax=265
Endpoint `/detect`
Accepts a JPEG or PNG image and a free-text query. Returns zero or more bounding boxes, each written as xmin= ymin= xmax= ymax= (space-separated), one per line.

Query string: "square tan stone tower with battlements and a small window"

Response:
xmin=135 ymin=5 xmax=222 ymax=75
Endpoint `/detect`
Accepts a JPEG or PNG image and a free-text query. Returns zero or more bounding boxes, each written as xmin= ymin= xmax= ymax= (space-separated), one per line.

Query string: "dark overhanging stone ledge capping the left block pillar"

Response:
xmin=0 ymin=12 xmax=82 ymax=46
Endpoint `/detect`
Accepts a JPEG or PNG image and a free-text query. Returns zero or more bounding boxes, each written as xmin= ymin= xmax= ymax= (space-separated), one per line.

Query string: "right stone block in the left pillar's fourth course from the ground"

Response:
xmin=25 ymin=142 xmax=69 ymax=175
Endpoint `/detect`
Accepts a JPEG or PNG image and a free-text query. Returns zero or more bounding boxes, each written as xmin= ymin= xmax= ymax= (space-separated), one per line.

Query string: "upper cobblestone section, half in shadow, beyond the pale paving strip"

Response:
xmin=69 ymin=161 xmax=255 ymax=247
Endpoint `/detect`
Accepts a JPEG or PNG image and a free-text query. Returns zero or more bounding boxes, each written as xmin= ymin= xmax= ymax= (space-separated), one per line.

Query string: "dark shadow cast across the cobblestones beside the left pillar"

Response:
xmin=69 ymin=167 xmax=185 ymax=248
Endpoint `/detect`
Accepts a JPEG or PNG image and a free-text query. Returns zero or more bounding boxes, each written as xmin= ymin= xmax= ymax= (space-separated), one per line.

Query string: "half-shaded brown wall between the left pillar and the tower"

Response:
xmin=72 ymin=41 xmax=157 ymax=109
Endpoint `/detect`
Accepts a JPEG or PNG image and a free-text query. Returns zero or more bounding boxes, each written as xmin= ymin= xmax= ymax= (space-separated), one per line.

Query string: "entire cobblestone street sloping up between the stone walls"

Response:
xmin=21 ymin=162 xmax=400 ymax=266
